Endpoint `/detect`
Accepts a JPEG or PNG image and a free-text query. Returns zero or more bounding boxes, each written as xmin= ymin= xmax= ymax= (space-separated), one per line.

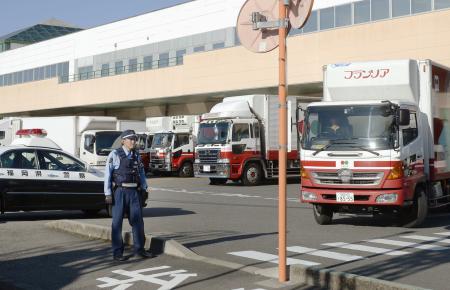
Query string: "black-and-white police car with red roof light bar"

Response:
xmin=0 ymin=129 xmax=108 ymax=215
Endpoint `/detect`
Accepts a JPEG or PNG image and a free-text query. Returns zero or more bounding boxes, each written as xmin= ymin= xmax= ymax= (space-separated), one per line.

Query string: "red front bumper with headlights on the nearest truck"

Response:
xmin=300 ymin=186 xmax=405 ymax=206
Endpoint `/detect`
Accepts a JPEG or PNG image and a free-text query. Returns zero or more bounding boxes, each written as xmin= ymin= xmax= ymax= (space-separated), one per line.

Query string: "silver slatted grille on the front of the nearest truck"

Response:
xmin=312 ymin=172 xmax=384 ymax=186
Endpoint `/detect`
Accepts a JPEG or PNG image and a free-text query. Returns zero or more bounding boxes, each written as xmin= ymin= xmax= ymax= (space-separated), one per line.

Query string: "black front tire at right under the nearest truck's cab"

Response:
xmin=400 ymin=187 xmax=428 ymax=228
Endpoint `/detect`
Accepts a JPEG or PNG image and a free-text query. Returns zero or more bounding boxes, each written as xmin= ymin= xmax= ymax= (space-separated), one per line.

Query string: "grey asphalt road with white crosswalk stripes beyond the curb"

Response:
xmin=0 ymin=177 xmax=450 ymax=289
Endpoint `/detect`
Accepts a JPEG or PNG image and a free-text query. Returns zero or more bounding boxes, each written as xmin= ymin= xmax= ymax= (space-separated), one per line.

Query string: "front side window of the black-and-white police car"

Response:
xmin=38 ymin=150 xmax=86 ymax=171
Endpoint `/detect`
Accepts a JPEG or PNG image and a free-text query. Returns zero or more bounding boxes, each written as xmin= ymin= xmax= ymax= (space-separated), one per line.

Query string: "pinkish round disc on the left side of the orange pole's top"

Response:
xmin=236 ymin=0 xmax=279 ymax=53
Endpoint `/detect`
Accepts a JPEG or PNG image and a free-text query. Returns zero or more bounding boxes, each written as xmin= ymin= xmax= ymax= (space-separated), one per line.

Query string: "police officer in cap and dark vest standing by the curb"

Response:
xmin=105 ymin=130 xmax=153 ymax=262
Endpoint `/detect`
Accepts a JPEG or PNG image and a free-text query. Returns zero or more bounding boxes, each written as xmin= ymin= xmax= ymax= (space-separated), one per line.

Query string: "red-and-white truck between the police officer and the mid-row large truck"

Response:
xmin=150 ymin=115 xmax=199 ymax=177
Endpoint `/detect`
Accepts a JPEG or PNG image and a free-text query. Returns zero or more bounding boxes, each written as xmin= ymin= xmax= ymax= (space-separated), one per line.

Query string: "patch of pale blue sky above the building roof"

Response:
xmin=0 ymin=0 xmax=190 ymax=36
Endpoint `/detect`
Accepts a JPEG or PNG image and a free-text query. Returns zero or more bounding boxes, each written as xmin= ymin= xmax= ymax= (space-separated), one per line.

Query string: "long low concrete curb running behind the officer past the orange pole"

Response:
xmin=45 ymin=220 xmax=428 ymax=290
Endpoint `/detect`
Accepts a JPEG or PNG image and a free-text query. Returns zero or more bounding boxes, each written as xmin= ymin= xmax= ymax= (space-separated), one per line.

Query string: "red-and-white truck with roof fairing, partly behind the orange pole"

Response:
xmin=194 ymin=95 xmax=300 ymax=185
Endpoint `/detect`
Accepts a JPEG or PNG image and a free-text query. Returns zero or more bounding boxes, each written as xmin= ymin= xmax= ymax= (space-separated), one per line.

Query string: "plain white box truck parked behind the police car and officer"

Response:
xmin=20 ymin=116 xmax=121 ymax=166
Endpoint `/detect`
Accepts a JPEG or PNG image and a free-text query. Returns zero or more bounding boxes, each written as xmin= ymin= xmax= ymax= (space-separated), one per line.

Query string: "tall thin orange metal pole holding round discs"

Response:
xmin=278 ymin=0 xmax=289 ymax=282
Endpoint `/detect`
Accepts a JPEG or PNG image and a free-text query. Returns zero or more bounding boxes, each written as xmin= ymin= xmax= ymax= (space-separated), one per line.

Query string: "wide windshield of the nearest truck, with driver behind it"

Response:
xmin=302 ymin=104 xmax=398 ymax=152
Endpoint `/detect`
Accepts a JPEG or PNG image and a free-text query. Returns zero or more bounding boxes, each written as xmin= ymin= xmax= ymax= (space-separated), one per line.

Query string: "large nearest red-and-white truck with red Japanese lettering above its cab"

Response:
xmin=301 ymin=60 xmax=450 ymax=227
